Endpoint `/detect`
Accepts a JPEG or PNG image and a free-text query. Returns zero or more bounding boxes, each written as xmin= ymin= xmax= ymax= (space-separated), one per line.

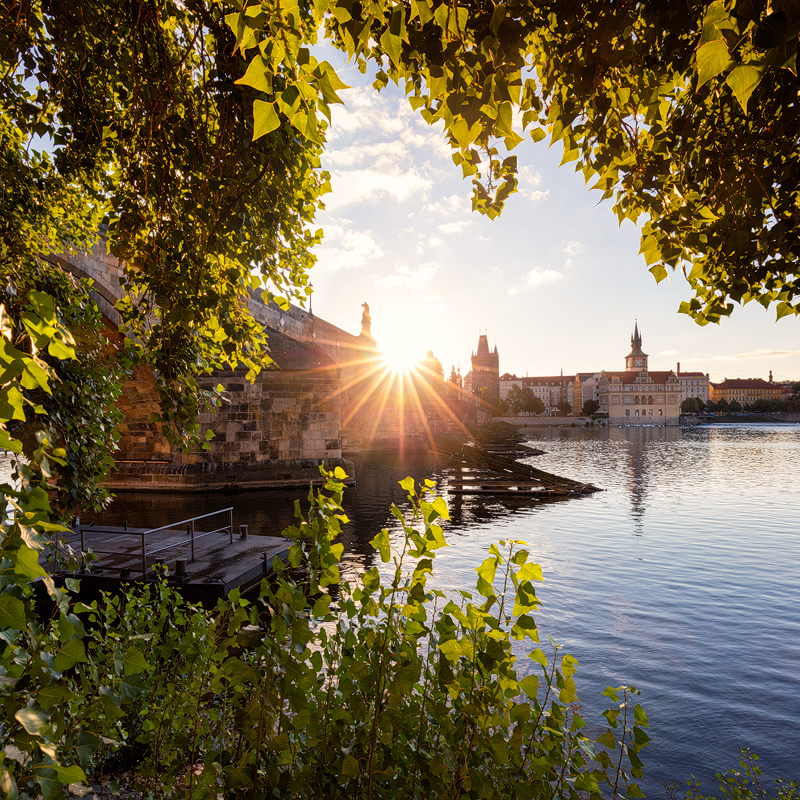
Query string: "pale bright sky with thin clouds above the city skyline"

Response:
xmin=304 ymin=45 xmax=800 ymax=381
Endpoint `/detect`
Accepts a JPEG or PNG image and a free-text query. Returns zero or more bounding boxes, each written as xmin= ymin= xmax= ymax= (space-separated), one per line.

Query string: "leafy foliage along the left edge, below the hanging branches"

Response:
xmin=0 ymin=288 xmax=143 ymax=798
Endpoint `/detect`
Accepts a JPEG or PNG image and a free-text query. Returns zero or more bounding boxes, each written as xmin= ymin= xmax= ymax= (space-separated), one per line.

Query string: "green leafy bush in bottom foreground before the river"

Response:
xmin=48 ymin=471 xmax=648 ymax=800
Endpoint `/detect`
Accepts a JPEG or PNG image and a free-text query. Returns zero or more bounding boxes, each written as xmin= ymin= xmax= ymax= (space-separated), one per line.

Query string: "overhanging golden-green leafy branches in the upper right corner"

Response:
xmin=214 ymin=0 xmax=800 ymax=324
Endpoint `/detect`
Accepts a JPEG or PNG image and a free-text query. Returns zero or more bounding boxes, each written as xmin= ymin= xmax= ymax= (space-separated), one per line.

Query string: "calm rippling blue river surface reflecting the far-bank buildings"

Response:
xmin=12 ymin=425 xmax=800 ymax=797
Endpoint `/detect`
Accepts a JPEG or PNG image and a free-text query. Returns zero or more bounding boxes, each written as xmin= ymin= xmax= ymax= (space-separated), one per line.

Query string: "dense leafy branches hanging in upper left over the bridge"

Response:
xmin=0 ymin=0 xmax=334 ymax=444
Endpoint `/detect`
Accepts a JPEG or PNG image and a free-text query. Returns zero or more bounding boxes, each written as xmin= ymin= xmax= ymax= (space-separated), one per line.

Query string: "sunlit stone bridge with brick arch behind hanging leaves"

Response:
xmin=48 ymin=240 xmax=475 ymax=491
